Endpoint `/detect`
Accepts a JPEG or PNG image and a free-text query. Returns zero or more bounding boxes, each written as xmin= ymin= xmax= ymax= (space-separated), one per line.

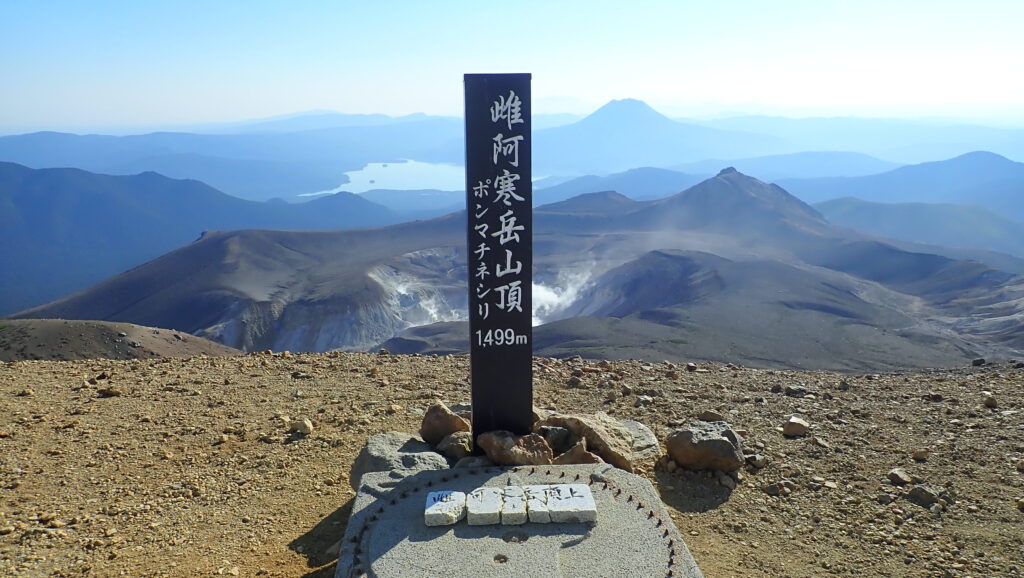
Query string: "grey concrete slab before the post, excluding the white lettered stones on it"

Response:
xmin=335 ymin=464 xmax=702 ymax=578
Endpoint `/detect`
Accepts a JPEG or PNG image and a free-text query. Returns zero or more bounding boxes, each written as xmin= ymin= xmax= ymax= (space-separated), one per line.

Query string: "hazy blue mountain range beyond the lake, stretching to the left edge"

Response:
xmin=0 ymin=118 xmax=463 ymax=200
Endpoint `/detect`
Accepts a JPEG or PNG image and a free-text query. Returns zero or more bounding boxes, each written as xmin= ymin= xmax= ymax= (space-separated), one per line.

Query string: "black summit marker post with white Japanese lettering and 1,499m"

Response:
xmin=464 ymin=74 xmax=534 ymax=442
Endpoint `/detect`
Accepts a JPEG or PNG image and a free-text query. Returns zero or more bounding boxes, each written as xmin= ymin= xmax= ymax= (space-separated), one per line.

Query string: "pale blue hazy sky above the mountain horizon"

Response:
xmin=0 ymin=0 xmax=1024 ymax=132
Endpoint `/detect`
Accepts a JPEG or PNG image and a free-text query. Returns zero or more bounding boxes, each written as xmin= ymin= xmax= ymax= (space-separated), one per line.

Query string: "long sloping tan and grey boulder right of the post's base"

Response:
xmin=534 ymin=412 xmax=657 ymax=472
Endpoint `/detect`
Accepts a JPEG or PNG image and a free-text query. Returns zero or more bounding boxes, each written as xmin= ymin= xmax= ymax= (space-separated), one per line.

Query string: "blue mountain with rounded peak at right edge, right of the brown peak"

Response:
xmin=778 ymin=152 xmax=1024 ymax=220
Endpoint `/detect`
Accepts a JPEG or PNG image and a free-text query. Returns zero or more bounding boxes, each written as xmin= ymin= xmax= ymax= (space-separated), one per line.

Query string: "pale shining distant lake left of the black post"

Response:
xmin=299 ymin=160 xmax=466 ymax=197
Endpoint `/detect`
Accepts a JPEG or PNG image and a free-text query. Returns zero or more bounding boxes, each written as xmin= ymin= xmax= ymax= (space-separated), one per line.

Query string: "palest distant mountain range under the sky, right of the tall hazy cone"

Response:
xmin=686 ymin=116 xmax=1024 ymax=163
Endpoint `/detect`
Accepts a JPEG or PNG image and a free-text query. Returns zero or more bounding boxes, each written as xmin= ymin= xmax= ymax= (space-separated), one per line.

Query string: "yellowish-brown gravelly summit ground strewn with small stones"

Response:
xmin=0 ymin=353 xmax=1024 ymax=577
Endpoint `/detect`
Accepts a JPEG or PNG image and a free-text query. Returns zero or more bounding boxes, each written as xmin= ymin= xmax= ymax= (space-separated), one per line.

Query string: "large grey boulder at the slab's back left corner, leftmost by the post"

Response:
xmin=349 ymin=431 xmax=449 ymax=490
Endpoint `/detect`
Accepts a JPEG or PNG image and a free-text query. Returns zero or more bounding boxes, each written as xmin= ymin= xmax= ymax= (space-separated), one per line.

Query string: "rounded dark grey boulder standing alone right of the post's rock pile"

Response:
xmin=665 ymin=421 xmax=743 ymax=471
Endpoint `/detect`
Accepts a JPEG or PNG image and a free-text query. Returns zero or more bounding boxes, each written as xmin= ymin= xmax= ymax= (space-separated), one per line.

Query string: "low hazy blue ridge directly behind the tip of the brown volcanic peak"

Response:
xmin=673 ymin=151 xmax=900 ymax=182
